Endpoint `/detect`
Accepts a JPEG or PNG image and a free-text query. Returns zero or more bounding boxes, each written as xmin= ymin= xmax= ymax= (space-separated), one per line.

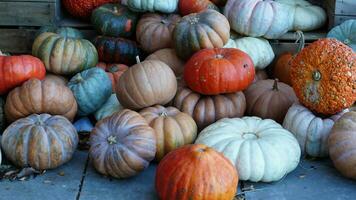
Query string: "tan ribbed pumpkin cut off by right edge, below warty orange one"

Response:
xmin=328 ymin=112 xmax=356 ymax=179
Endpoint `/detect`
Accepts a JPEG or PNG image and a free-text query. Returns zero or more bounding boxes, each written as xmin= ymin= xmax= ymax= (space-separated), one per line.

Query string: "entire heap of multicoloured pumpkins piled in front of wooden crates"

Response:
xmin=0 ymin=0 xmax=356 ymax=199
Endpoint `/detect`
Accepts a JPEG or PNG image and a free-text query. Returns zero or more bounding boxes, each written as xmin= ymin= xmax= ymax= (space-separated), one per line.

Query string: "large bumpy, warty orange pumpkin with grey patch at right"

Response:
xmin=290 ymin=38 xmax=356 ymax=115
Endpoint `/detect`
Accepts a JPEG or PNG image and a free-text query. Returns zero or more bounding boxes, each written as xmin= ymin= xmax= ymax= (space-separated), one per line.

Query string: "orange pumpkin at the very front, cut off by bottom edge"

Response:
xmin=155 ymin=145 xmax=238 ymax=200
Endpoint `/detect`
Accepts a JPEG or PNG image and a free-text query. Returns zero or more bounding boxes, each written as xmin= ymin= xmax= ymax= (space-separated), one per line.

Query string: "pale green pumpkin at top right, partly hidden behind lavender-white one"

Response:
xmin=275 ymin=0 xmax=327 ymax=31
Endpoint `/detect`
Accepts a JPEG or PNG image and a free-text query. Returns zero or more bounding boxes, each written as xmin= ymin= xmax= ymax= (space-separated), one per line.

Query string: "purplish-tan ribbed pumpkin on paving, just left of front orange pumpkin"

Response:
xmin=89 ymin=109 xmax=156 ymax=178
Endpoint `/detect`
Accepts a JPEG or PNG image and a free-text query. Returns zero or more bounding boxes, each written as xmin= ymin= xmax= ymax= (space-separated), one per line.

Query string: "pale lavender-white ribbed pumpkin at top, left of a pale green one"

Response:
xmin=224 ymin=0 xmax=292 ymax=39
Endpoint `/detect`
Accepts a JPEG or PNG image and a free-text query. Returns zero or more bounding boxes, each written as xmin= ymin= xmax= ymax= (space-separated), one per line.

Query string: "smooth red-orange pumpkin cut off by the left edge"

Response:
xmin=0 ymin=52 xmax=46 ymax=95
